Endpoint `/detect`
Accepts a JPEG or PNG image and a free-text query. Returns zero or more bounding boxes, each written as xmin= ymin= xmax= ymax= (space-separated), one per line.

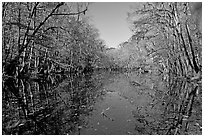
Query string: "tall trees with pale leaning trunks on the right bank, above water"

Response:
xmin=128 ymin=2 xmax=202 ymax=79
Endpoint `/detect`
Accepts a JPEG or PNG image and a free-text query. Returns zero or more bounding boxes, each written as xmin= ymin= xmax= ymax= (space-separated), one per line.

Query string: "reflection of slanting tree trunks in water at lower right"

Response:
xmin=133 ymin=78 xmax=202 ymax=135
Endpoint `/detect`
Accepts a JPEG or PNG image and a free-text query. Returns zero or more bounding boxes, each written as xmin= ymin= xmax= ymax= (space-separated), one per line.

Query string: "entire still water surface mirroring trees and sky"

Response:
xmin=2 ymin=71 xmax=202 ymax=135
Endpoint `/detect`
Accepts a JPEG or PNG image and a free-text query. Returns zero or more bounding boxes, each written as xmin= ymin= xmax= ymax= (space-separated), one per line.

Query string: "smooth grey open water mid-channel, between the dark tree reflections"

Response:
xmin=80 ymin=73 xmax=163 ymax=135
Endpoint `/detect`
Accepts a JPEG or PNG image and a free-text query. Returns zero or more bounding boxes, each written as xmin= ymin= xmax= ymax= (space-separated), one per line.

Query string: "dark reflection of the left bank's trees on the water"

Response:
xmin=3 ymin=74 xmax=107 ymax=135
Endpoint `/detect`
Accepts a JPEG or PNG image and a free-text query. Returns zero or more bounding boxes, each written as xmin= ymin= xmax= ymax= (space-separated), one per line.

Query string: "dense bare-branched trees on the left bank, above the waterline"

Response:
xmin=2 ymin=2 xmax=105 ymax=76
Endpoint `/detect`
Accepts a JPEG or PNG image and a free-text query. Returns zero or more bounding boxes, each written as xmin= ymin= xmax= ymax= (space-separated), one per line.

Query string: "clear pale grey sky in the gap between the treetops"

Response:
xmin=87 ymin=2 xmax=135 ymax=48
